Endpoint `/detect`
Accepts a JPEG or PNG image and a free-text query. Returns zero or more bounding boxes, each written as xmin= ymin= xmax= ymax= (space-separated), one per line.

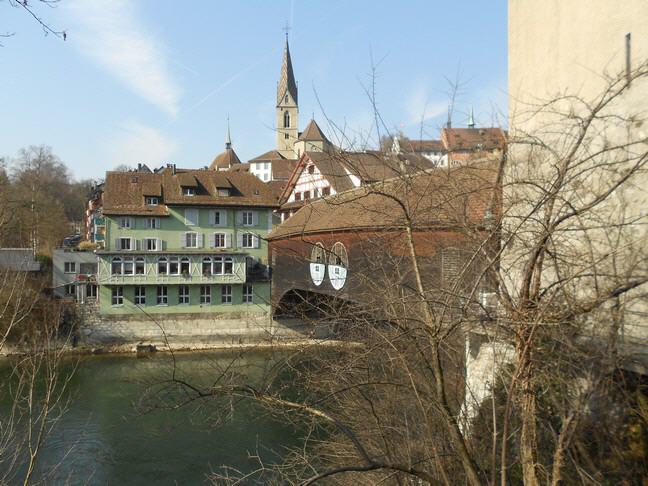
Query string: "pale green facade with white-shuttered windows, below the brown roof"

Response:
xmin=97 ymin=206 xmax=272 ymax=315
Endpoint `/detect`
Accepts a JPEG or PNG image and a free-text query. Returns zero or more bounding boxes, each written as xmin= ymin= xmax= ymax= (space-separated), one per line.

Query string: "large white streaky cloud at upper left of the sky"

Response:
xmin=66 ymin=0 xmax=180 ymax=115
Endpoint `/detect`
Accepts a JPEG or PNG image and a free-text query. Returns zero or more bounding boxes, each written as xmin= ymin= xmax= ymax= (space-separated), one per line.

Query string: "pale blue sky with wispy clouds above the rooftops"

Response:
xmin=0 ymin=0 xmax=507 ymax=179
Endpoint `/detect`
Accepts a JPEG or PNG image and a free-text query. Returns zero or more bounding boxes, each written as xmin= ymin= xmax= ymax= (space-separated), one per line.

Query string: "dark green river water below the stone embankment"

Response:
xmin=0 ymin=352 xmax=299 ymax=485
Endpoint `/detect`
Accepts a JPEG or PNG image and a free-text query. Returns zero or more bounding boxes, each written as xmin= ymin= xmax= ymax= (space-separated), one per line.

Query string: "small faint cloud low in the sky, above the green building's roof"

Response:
xmin=109 ymin=120 xmax=178 ymax=167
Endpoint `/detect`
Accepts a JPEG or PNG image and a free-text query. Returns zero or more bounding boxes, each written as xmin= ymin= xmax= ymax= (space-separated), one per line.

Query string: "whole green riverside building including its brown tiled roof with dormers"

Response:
xmin=97 ymin=165 xmax=277 ymax=316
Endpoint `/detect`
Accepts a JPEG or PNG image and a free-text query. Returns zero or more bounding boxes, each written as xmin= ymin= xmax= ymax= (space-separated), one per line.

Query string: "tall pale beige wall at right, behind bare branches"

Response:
xmin=504 ymin=0 xmax=648 ymax=352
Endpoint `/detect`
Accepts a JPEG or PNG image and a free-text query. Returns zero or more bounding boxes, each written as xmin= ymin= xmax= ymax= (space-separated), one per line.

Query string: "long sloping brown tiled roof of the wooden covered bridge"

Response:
xmin=268 ymin=155 xmax=501 ymax=240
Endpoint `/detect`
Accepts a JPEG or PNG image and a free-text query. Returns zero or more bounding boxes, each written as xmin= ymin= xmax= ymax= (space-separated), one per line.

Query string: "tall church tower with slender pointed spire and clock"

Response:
xmin=276 ymin=34 xmax=299 ymax=159
